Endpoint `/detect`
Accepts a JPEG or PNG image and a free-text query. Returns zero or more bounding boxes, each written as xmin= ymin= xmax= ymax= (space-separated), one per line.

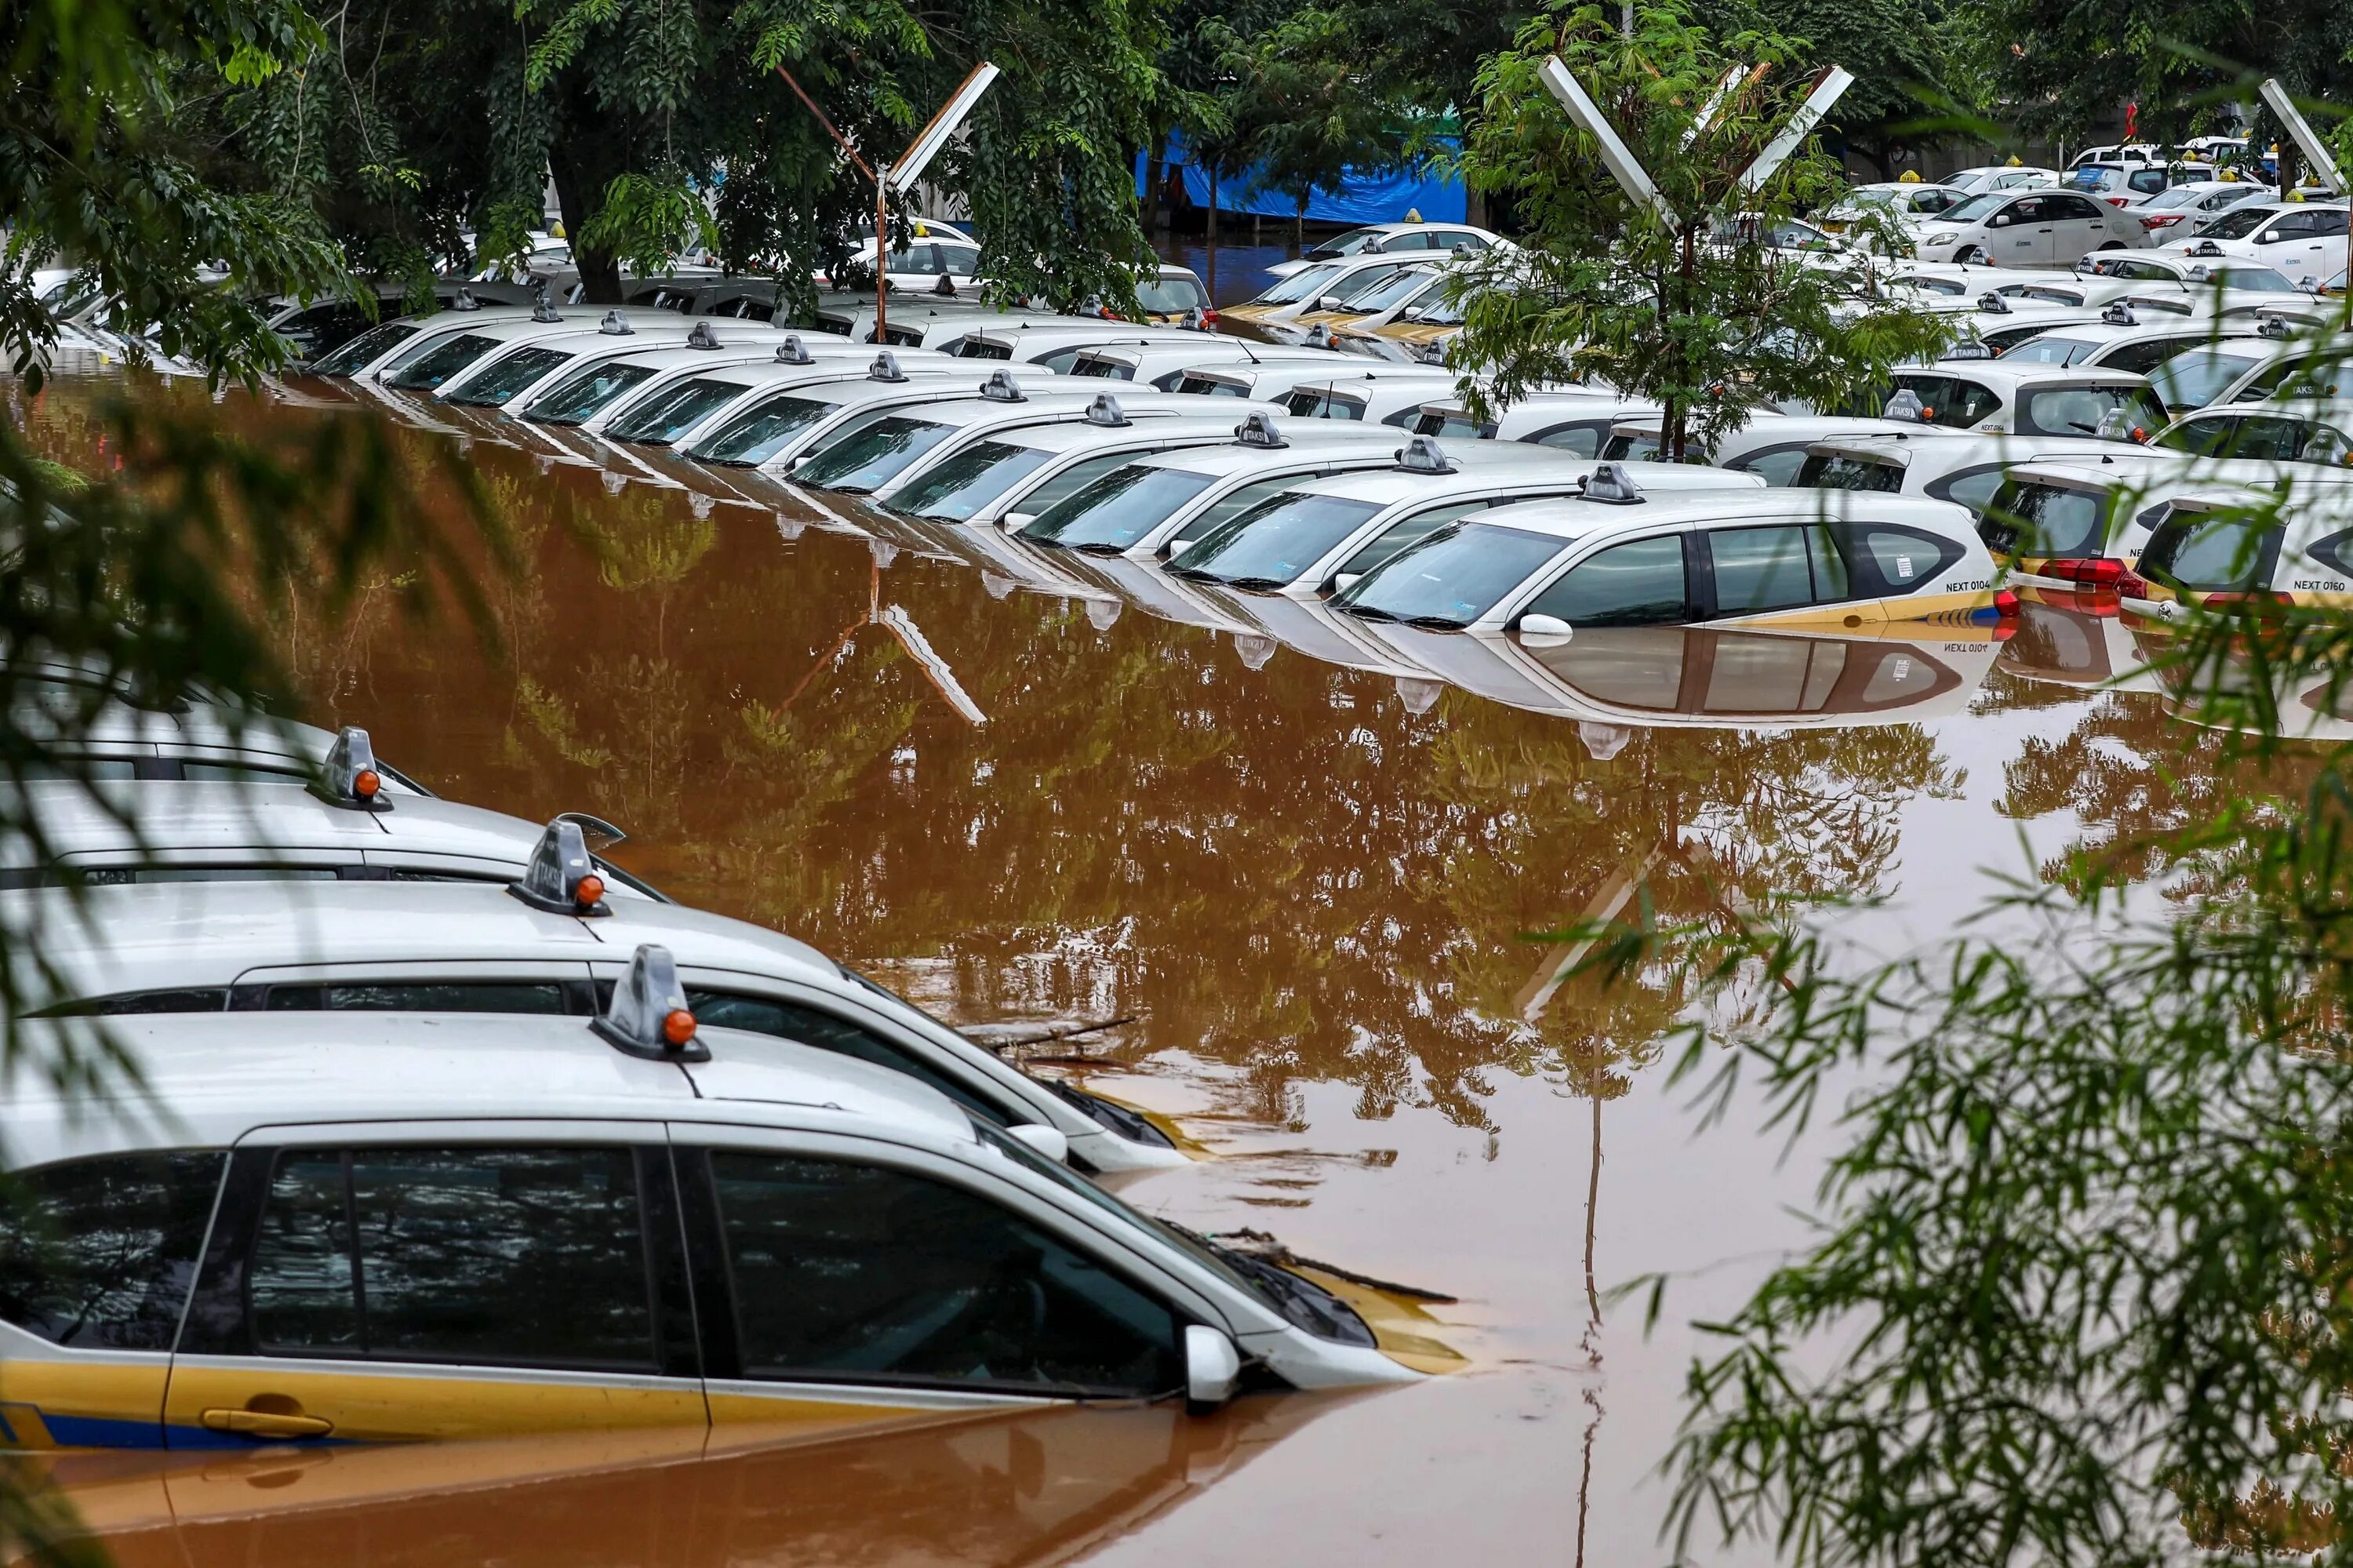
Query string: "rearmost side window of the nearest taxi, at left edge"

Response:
xmin=0 ymin=1149 xmax=226 ymax=1352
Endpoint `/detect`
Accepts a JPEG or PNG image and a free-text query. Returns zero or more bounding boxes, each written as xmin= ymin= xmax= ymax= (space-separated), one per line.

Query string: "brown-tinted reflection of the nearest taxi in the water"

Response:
xmin=35 ymin=1396 xmax=1344 ymax=1568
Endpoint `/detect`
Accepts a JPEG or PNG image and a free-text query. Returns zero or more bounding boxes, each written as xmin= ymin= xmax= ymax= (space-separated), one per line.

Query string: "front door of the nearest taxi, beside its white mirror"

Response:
xmin=671 ymin=1123 xmax=1219 ymax=1429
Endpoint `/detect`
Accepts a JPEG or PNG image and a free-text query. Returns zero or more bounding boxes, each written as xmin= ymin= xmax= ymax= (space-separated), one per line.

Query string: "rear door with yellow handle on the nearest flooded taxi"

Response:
xmin=162 ymin=1111 xmax=706 ymax=1448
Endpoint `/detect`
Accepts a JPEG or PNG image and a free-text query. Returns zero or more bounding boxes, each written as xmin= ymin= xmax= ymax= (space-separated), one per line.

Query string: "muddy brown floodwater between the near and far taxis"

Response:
xmin=4 ymin=384 xmax=2259 ymax=1568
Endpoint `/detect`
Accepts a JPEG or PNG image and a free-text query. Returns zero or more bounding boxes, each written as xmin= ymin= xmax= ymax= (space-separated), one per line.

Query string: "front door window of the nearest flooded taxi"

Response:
xmin=708 ymin=1149 xmax=1184 ymax=1396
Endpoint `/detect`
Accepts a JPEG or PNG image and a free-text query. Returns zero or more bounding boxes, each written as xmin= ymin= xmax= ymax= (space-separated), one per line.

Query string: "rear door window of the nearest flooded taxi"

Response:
xmin=247 ymin=1147 xmax=659 ymax=1373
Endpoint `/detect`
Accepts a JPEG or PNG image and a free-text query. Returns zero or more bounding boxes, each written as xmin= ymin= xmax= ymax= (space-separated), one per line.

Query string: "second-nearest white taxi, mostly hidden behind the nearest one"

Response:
xmin=0 ymin=866 xmax=1186 ymax=1173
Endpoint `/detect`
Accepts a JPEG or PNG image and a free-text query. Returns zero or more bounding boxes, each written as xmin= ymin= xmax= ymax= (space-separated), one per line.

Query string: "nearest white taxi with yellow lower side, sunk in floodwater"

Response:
xmin=0 ymin=949 xmax=1452 ymax=1450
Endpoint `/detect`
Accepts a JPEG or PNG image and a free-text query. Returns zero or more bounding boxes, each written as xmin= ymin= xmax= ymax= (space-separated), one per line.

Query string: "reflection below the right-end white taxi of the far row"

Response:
xmin=1374 ymin=621 xmax=2007 ymax=729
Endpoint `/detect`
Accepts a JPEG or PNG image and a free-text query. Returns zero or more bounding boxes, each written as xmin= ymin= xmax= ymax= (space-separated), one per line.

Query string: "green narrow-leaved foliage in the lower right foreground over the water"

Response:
xmin=1654 ymin=544 xmax=2353 ymax=1568
